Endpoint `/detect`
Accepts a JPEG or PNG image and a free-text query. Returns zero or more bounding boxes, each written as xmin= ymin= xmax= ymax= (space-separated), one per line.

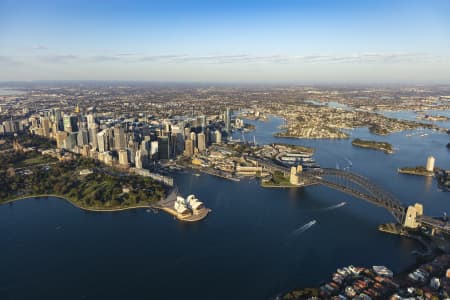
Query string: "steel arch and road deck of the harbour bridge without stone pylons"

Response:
xmin=250 ymin=157 xmax=450 ymax=234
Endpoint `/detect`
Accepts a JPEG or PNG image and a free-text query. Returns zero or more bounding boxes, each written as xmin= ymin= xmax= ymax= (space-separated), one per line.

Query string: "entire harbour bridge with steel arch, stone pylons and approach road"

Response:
xmin=257 ymin=159 xmax=450 ymax=234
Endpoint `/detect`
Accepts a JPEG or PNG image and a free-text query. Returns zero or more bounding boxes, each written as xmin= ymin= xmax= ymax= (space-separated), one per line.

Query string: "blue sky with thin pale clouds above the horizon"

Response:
xmin=0 ymin=0 xmax=450 ymax=83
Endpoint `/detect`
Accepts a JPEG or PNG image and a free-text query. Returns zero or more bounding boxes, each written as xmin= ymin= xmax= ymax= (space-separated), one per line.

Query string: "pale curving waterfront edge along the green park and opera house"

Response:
xmin=0 ymin=194 xmax=211 ymax=222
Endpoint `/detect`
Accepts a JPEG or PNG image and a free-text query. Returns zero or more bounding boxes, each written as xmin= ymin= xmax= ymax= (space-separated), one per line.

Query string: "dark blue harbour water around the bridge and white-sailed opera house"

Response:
xmin=0 ymin=118 xmax=450 ymax=299
